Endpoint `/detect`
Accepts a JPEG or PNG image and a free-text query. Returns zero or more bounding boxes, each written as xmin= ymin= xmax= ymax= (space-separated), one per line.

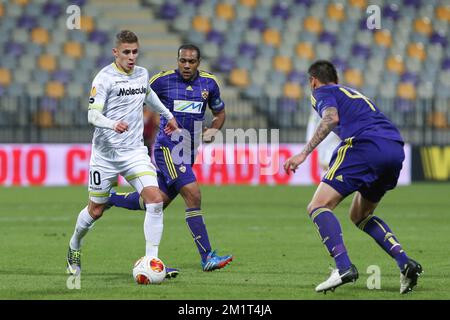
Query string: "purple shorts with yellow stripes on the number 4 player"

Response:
xmin=322 ymin=137 xmax=405 ymax=203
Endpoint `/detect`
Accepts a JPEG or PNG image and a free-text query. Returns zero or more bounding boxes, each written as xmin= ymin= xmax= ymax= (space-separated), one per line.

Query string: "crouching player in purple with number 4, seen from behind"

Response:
xmin=284 ymin=60 xmax=422 ymax=294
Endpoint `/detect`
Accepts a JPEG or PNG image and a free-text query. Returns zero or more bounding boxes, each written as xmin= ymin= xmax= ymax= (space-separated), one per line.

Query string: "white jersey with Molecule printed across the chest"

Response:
xmin=89 ymin=62 xmax=151 ymax=149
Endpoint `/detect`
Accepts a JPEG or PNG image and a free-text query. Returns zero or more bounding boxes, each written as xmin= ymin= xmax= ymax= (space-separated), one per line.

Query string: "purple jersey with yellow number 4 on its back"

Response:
xmin=311 ymin=84 xmax=403 ymax=142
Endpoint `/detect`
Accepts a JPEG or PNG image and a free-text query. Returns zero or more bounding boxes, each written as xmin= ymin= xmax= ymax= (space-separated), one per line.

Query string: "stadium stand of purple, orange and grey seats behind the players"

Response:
xmin=0 ymin=0 xmax=450 ymax=141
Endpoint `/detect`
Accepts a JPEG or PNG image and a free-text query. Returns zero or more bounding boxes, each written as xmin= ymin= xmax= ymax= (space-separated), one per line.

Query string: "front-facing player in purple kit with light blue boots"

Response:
xmin=109 ymin=44 xmax=233 ymax=277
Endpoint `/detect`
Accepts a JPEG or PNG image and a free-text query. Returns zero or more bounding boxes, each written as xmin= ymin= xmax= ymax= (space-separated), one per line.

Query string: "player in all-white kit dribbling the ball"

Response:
xmin=67 ymin=30 xmax=178 ymax=275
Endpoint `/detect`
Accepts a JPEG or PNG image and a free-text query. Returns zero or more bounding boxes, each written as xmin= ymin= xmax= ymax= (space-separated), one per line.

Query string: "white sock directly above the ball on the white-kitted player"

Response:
xmin=144 ymin=202 xmax=164 ymax=257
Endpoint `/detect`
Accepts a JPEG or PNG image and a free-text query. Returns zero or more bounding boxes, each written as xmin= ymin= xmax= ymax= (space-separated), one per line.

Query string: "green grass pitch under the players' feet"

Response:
xmin=0 ymin=184 xmax=450 ymax=300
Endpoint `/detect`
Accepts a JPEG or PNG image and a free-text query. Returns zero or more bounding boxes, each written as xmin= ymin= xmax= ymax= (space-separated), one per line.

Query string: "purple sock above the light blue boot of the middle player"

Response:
xmin=186 ymin=208 xmax=211 ymax=261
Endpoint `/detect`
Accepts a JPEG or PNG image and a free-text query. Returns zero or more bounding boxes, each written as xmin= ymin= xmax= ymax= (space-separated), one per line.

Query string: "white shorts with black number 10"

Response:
xmin=88 ymin=145 xmax=158 ymax=203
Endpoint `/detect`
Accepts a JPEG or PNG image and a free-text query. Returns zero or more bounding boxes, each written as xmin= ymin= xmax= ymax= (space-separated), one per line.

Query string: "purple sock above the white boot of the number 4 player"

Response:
xmin=310 ymin=208 xmax=352 ymax=271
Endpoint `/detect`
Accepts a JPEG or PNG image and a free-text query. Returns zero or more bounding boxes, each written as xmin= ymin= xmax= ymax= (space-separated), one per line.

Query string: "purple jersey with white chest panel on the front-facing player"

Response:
xmin=150 ymin=70 xmax=225 ymax=146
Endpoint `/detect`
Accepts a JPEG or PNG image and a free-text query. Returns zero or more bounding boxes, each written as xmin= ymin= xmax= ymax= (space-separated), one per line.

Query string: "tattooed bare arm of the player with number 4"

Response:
xmin=284 ymin=107 xmax=339 ymax=173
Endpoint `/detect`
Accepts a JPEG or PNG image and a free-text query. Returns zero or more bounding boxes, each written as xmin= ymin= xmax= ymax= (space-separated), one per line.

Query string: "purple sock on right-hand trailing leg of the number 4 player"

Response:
xmin=356 ymin=215 xmax=409 ymax=270
